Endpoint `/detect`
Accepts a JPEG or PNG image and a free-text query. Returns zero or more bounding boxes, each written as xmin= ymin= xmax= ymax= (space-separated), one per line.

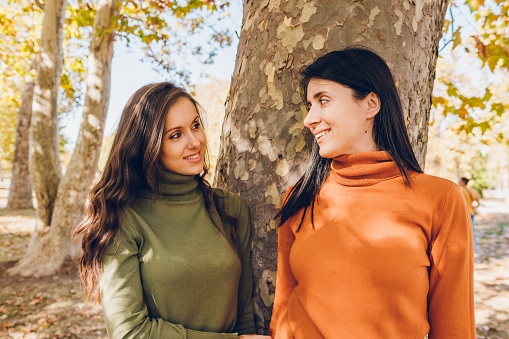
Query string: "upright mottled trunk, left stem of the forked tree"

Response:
xmin=8 ymin=0 xmax=67 ymax=274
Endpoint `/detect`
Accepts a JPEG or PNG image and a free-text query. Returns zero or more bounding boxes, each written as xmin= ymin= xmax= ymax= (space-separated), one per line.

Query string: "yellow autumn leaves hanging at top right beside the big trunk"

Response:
xmin=433 ymin=0 xmax=509 ymax=142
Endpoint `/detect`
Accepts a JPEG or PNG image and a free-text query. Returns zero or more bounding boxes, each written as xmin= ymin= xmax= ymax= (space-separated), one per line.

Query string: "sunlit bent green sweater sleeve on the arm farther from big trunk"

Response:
xmin=100 ymin=212 xmax=238 ymax=339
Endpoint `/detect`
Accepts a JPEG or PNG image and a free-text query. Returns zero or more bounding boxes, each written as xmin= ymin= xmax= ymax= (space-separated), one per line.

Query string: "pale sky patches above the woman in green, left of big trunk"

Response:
xmin=62 ymin=0 xmax=242 ymax=149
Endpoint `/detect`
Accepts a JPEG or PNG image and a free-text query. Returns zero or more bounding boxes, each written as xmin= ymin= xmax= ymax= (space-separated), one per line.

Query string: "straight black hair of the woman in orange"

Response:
xmin=276 ymin=47 xmax=422 ymax=230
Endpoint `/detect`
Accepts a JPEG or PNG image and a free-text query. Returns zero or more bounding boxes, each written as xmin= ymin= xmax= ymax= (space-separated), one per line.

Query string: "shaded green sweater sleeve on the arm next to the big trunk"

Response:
xmin=234 ymin=196 xmax=256 ymax=334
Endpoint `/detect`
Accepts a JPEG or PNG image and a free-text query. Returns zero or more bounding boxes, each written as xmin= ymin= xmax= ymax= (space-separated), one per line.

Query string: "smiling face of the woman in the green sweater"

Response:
xmin=159 ymin=98 xmax=206 ymax=175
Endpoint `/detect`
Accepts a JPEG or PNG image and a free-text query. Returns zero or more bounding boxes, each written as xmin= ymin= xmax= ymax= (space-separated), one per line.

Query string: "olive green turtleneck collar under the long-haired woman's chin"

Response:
xmin=144 ymin=169 xmax=203 ymax=201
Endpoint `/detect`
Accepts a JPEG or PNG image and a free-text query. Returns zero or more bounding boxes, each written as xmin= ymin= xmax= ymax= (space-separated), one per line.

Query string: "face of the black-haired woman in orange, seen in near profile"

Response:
xmin=304 ymin=78 xmax=380 ymax=158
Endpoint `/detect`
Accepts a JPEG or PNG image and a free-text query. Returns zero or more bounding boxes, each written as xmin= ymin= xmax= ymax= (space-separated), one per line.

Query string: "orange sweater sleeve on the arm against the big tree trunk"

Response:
xmin=269 ymin=215 xmax=297 ymax=337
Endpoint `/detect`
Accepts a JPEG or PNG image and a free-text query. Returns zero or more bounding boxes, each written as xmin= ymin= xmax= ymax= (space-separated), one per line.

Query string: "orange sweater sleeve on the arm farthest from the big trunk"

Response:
xmin=428 ymin=187 xmax=476 ymax=339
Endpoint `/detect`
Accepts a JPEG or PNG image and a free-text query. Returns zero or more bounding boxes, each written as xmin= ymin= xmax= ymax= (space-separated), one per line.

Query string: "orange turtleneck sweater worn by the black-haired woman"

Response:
xmin=270 ymin=152 xmax=475 ymax=339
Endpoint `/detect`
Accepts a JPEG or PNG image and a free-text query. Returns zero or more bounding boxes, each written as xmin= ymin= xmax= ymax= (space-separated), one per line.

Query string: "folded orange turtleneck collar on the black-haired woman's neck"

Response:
xmin=330 ymin=151 xmax=401 ymax=186
